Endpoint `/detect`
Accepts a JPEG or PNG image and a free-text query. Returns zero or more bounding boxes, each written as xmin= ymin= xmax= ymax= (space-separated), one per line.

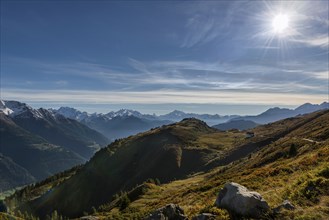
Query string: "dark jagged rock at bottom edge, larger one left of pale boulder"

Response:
xmin=145 ymin=204 xmax=187 ymax=220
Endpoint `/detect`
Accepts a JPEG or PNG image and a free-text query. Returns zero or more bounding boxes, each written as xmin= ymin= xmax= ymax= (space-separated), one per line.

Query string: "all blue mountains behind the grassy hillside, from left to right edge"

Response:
xmin=0 ymin=101 xmax=329 ymax=190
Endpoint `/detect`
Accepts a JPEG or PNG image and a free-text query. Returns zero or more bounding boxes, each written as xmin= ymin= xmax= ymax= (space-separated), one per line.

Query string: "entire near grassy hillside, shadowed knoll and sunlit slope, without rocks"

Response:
xmin=8 ymin=111 xmax=329 ymax=219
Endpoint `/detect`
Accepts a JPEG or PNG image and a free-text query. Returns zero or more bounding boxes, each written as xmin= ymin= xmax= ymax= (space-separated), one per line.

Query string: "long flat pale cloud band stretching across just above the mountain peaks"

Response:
xmin=2 ymin=89 xmax=326 ymax=105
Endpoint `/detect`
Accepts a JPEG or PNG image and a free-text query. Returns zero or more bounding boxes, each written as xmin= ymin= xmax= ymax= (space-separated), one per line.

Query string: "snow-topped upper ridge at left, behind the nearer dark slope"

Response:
xmin=0 ymin=101 xmax=109 ymax=159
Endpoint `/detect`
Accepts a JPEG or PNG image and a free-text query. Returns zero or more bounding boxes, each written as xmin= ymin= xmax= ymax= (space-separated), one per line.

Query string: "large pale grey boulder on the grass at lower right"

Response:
xmin=215 ymin=182 xmax=270 ymax=219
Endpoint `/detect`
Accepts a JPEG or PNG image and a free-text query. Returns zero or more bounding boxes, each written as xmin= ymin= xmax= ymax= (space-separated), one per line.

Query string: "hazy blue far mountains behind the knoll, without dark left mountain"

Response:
xmin=51 ymin=102 xmax=329 ymax=134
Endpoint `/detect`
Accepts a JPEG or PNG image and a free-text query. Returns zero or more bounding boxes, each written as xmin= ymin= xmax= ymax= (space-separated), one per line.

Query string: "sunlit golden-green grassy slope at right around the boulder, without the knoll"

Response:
xmin=96 ymin=112 xmax=329 ymax=219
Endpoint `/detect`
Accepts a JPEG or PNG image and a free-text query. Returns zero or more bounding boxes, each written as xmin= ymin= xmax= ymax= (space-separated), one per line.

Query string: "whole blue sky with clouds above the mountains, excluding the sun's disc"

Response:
xmin=1 ymin=0 xmax=329 ymax=114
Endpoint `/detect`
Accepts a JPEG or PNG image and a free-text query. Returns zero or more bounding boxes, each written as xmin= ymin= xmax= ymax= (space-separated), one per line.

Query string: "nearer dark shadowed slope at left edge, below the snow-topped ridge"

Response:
xmin=0 ymin=113 xmax=84 ymax=190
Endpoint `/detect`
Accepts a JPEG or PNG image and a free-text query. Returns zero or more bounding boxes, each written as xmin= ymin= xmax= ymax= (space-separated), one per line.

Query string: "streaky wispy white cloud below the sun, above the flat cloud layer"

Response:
xmin=125 ymin=58 xmax=327 ymax=93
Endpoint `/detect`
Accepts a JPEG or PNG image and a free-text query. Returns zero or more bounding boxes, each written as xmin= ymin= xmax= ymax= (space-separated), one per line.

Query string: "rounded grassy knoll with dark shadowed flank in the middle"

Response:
xmin=16 ymin=119 xmax=243 ymax=216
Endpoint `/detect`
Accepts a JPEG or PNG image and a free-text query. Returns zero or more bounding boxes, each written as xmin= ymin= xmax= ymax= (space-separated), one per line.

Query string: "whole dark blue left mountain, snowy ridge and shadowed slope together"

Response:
xmin=0 ymin=101 xmax=109 ymax=190
